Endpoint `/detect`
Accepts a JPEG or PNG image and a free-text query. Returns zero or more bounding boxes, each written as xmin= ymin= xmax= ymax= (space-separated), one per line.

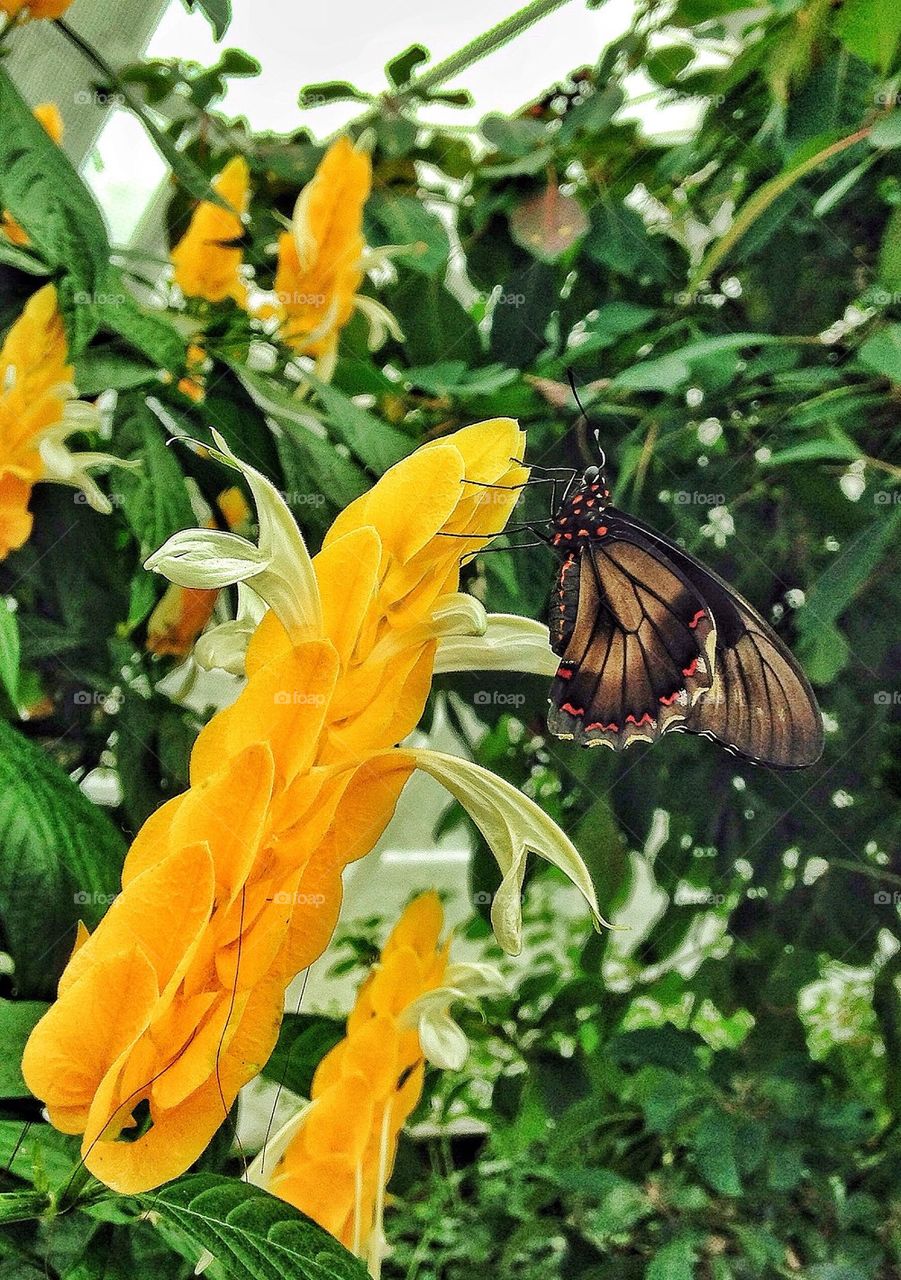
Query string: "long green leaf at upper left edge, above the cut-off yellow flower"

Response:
xmin=0 ymin=67 xmax=110 ymax=351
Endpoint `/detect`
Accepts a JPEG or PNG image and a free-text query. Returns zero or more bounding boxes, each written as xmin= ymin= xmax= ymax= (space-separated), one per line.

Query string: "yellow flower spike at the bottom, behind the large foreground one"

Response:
xmin=254 ymin=893 xmax=503 ymax=1274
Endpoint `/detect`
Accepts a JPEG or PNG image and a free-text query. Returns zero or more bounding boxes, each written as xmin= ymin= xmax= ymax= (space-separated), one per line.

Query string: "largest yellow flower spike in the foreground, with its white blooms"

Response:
xmin=23 ymin=420 xmax=598 ymax=1193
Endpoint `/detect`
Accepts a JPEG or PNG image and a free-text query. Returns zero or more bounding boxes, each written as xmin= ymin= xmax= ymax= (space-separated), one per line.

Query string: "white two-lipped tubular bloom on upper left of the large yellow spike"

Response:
xmin=145 ymin=431 xmax=323 ymax=639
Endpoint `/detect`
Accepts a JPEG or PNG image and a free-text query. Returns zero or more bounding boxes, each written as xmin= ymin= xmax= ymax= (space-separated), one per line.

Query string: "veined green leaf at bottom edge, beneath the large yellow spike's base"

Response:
xmin=137 ymin=1174 xmax=369 ymax=1280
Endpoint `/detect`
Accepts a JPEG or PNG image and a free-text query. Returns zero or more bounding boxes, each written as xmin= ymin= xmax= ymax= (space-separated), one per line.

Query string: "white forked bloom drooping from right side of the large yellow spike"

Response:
xmin=410 ymin=749 xmax=607 ymax=955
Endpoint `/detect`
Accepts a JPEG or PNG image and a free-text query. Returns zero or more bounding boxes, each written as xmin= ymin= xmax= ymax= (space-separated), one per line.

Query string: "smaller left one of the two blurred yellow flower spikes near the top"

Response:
xmin=170 ymin=156 xmax=250 ymax=307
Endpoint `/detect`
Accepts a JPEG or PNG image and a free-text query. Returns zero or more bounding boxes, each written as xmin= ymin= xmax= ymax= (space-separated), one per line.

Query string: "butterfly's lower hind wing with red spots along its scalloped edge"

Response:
xmin=548 ymin=532 xmax=715 ymax=750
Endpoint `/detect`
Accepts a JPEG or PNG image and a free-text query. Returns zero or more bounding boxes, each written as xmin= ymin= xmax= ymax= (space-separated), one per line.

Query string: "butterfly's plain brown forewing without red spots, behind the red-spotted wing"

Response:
xmin=588 ymin=511 xmax=823 ymax=769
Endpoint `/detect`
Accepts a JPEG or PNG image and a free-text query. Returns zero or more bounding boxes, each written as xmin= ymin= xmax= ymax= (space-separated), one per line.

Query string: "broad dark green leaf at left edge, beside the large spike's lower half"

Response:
xmin=0 ymin=721 xmax=124 ymax=996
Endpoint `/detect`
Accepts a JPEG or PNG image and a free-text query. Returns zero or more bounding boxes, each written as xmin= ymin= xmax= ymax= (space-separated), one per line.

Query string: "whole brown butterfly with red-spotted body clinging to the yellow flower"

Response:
xmin=548 ymin=466 xmax=823 ymax=769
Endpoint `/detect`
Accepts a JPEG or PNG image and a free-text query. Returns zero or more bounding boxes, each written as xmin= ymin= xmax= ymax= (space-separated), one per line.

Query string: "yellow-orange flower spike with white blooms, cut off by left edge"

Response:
xmin=0 ymin=284 xmax=127 ymax=558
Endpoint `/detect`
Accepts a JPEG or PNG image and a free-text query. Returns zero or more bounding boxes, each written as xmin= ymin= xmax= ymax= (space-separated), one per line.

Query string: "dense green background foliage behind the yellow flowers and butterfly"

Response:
xmin=0 ymin=0 xmax=901 ymax=1280
